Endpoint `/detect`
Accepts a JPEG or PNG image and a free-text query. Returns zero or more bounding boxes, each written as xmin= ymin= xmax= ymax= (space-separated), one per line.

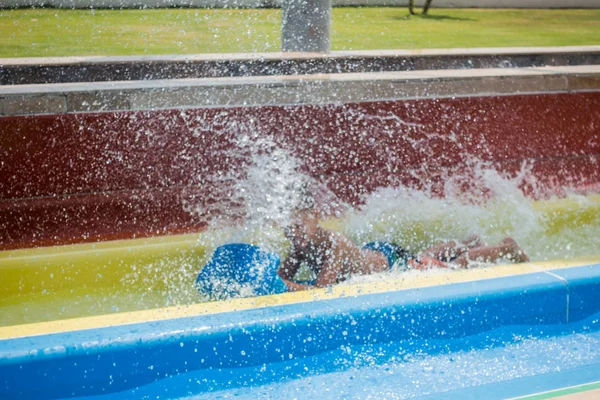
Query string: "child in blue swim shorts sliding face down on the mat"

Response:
xmin=278 ymin=204 xmax=529 ymax=291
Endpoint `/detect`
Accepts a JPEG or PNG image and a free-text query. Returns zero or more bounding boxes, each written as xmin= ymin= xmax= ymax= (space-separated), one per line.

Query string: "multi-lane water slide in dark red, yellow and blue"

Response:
xmin=0 ymin=50 xmax=600 ymax=398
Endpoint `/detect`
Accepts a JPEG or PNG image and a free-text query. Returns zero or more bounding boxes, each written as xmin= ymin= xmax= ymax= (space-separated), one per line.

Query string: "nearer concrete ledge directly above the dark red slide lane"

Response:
xmin=0 ymin=65 xmax=600 ymax=116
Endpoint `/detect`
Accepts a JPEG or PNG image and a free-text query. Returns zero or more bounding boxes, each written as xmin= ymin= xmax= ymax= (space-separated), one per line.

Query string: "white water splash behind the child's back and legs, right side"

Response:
xmin=342 ymin=164 xmax=600 ymax=266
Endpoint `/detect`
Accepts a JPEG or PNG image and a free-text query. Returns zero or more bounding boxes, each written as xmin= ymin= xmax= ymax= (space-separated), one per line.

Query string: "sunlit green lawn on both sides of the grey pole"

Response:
xmin=0 ymin=7 xmax=600 ymax=57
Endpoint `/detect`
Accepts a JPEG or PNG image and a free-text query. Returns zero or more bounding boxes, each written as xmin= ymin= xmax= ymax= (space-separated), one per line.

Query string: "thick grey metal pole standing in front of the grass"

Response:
xmin=281 ymin=0 xmax=331 ymax=53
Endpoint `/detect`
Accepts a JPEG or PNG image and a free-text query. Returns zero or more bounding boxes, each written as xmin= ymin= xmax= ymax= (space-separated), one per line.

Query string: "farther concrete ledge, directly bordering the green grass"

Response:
xmin=0 ymin=46 xmax=600 ymax=85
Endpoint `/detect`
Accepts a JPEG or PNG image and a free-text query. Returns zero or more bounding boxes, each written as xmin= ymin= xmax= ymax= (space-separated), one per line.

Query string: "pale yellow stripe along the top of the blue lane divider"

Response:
xmin=0 ymin=255 xmax=600 ymax=339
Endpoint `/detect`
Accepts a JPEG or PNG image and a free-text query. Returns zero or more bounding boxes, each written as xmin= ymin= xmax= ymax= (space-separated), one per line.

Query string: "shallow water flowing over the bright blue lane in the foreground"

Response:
xmin=92 ymin=313 xmax=600 ymax=400
